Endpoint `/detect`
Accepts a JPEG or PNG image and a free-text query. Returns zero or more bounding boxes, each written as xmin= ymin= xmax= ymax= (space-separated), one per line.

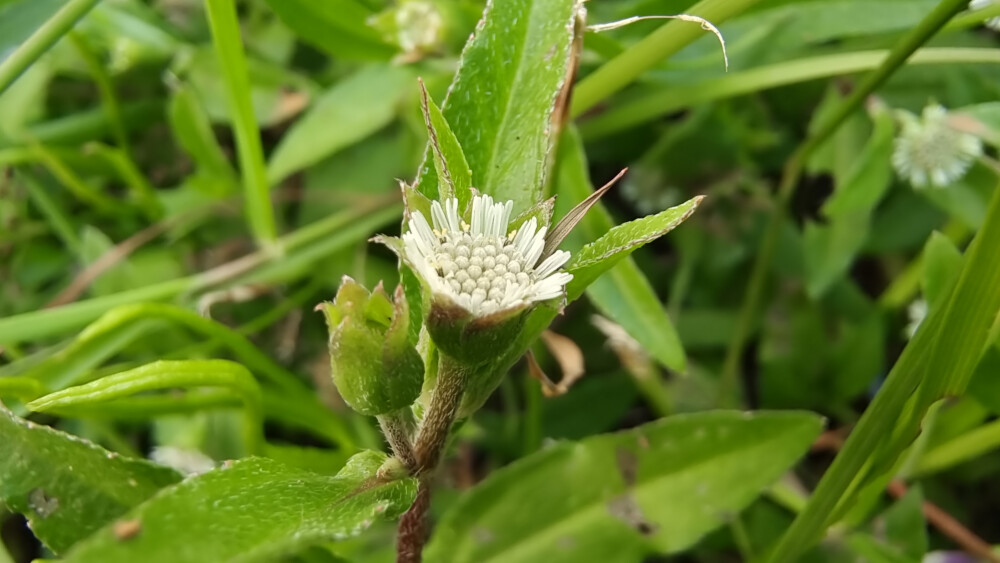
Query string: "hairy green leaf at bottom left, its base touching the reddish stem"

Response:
xmin=64 ymin=451 xmax=416 ymax=563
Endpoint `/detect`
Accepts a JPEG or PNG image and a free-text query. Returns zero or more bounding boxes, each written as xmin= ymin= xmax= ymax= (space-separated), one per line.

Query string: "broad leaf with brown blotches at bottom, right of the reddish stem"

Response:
xmin=426 ymin=411 xmax=822 ymax=563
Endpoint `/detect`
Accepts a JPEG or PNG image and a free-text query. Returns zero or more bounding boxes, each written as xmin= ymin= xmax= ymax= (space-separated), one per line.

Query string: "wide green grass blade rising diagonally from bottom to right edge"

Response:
xmin=768 ymin=184 xmax=1000 ymax=563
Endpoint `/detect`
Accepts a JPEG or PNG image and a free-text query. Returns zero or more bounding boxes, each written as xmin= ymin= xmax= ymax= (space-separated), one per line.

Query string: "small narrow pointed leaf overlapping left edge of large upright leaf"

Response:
xmin=418 ymin=82 xmax=472 ymax=209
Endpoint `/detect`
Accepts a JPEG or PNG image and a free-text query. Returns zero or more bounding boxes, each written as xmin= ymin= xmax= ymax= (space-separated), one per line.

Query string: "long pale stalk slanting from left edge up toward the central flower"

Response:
xmin=0 ymin=200 xmax=401 ymax=345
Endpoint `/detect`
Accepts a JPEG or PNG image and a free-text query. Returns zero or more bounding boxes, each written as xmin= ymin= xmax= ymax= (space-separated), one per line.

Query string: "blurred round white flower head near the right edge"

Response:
xmin=892 ymin=104 xmax=983 ymax=192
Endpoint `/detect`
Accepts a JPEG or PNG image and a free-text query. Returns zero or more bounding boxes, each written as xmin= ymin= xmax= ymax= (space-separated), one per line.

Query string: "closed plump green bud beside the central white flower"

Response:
xmin=317 ymin=276 xmax=424 ymax=416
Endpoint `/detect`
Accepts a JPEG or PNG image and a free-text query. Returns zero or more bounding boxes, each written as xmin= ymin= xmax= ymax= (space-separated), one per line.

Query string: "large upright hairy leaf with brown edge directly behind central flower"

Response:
xmin=417 ymin=0 xmax=577 ymax=212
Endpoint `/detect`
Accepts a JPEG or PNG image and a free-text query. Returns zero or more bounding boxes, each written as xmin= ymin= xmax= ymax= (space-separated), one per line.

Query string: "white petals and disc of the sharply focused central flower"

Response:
xmin=402 ymin=195 xmax=573 ymax=316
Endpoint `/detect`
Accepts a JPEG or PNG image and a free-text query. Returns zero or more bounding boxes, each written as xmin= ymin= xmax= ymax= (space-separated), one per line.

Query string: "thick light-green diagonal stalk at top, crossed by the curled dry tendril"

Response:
xmin=570 ymin=0 xmax=760 ymax=117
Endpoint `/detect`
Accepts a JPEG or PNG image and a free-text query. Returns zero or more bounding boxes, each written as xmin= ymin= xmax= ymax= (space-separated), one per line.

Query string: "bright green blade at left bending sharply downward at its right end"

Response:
xmin=28 ymin=360 xmax=264 ymax=453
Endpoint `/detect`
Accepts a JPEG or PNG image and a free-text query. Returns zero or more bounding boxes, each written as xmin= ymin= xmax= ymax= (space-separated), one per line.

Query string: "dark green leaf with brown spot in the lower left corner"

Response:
xmin=0 ymin=405 xmax=180 ymax=553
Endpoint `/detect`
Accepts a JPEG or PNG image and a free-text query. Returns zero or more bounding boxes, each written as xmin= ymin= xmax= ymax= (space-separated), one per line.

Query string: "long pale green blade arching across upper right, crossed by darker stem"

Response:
xmin=579 ymin=47 xmax=1000 ymax=141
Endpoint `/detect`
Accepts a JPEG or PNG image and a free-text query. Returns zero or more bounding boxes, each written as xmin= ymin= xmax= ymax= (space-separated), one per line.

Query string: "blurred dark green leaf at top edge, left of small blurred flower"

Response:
xmin=266 ymin=0 xmax=396 ymax=60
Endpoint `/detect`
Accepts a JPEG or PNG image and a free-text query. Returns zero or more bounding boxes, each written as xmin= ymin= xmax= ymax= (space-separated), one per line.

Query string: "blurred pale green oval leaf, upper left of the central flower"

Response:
xmin=267 ymin=65 xmax=413 ymax=184
